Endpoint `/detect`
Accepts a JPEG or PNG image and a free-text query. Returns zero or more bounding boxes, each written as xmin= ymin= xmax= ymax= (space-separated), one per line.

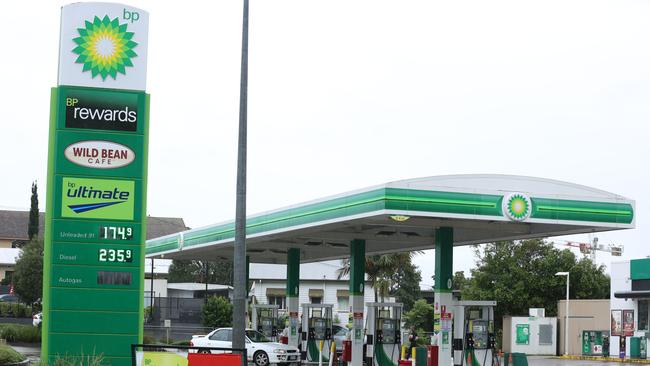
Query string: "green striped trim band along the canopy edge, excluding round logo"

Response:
xmin=146 ymin=188 xmax=634 ymax=254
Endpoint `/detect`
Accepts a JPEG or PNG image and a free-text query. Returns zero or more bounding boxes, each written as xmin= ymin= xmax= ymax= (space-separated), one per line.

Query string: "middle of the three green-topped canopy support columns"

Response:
xmin=349 ymin=239 xmax=366 ymax=366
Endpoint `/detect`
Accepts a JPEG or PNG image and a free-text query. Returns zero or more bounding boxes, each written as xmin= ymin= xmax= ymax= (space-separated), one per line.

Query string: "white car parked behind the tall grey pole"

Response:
xmin=190 ymin=328 xmax=300 ymax=366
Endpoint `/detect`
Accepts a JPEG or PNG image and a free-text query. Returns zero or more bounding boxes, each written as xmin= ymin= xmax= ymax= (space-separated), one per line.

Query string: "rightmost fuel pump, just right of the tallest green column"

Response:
xmin=452 ymin=301 xmax=499 ymax=366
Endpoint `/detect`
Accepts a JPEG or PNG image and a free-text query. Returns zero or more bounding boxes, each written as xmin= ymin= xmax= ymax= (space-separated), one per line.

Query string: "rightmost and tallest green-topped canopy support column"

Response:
xmin=433 ymin=227 xmax=454 ymax=366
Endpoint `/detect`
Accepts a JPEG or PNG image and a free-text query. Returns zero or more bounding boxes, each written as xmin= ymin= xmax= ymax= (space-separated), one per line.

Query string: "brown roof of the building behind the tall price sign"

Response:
xmin=0 ymin=210 xmax=189 ymax=240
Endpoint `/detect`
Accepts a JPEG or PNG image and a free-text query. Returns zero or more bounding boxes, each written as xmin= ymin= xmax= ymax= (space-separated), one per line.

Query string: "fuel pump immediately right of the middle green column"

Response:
xmin=366 ymin=302 xmax=403 ymax=366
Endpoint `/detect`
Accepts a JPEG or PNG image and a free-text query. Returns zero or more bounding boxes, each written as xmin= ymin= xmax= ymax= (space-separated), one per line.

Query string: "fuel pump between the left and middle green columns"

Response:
xmin=301 ymin=304 xmax=332 ymax=363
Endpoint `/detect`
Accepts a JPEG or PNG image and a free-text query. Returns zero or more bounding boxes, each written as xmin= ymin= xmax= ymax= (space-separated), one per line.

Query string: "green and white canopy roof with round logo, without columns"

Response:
xmin=146 ymin=175 xmax=635 ymax=263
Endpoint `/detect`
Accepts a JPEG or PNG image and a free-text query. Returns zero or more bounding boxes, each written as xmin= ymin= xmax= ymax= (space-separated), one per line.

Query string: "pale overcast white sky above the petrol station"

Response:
xmin=0 ymin=0 xmax=650 ymax=283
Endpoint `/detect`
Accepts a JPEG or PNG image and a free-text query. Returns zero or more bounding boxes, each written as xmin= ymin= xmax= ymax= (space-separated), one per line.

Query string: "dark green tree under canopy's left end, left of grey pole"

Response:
xmin=168 ymin=259 xmax=233 ymax=286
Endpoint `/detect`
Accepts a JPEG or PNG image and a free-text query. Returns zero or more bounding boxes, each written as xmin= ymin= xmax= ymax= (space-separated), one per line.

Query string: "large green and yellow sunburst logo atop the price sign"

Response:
xmin=72 ymin=15 xmax=138 ymax=80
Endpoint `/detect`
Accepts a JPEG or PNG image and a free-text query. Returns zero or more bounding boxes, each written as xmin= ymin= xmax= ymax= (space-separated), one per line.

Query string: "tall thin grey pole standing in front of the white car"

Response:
xmin=232 ymin=0 xmax=248 ymax=352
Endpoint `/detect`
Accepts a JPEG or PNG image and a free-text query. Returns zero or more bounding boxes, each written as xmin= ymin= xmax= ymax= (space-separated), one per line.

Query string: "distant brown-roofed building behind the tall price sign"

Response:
xmin=0 ymin=210 xmax=189 ymax=281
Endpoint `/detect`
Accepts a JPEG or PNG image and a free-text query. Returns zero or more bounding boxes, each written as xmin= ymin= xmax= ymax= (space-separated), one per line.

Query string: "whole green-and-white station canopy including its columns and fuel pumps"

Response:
xmin=146 ymin=175 xmax=635 ymax=366
